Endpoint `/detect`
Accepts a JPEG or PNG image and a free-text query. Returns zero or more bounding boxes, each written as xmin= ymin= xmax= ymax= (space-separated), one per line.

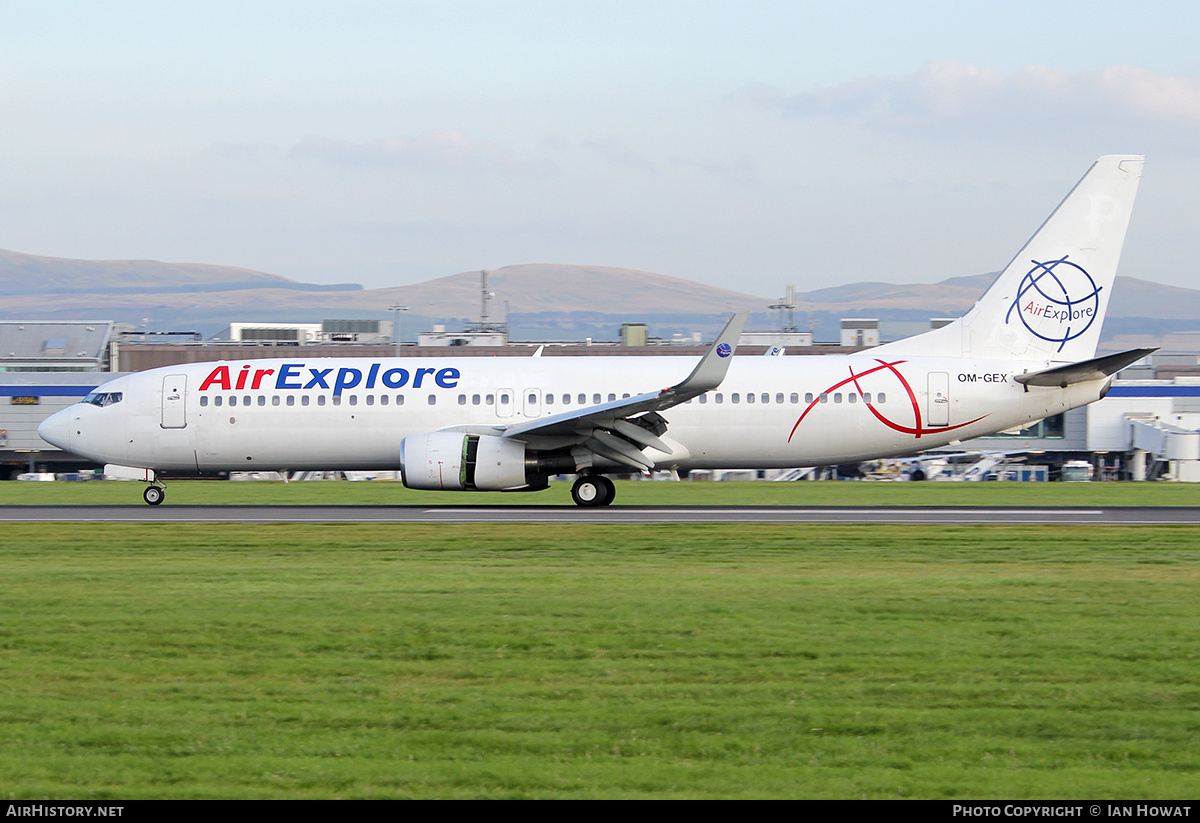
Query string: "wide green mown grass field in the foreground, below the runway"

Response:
xmin=0 ymin=523 xmax=1200 ymax=799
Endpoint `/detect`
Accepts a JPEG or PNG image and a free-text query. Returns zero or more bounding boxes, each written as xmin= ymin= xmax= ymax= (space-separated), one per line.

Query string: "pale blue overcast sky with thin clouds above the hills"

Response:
xmin=0 ymin=0 xmax=1200 ymax=300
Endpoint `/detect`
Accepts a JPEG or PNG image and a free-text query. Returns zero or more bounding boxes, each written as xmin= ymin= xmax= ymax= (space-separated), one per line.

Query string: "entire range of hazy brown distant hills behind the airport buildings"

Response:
xmin=0 ymin=251 xmax=1200 ymax=341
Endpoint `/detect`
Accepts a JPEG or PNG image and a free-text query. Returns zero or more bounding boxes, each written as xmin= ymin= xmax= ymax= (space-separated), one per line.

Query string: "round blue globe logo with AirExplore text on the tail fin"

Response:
xmin=1004 ymin=256 xmax=1103 ymax=352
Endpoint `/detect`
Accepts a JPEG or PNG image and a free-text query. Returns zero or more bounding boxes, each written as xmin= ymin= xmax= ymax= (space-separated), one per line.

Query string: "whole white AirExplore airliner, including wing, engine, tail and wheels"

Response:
xmin=38 ymin=155 xmax=1152 ymax=506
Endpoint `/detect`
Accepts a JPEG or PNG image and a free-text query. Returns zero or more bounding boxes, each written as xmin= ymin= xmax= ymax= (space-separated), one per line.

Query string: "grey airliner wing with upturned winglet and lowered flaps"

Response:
xmin=500 ymin=312 xmax=749 ymax=470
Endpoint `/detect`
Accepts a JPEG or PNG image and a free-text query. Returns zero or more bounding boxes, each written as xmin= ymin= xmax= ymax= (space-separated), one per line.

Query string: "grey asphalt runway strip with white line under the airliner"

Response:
xmin=0 ymin=504 xmax=1200 ymax=525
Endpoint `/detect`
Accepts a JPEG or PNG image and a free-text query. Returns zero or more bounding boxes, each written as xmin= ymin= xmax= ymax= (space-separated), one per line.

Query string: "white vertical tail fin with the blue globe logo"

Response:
xmin=878 ymin=155 xmax=1146 ymax=364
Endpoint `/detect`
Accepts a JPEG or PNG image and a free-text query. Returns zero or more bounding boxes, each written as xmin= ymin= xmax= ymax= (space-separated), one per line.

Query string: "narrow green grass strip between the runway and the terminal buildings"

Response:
xmin=0 ymin=480 xmax=1200 ymax=506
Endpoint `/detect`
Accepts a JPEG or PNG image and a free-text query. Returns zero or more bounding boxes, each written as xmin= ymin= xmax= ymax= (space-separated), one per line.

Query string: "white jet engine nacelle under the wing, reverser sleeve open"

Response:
xmin=400 ymin=432 xmax=532 ymax=492
